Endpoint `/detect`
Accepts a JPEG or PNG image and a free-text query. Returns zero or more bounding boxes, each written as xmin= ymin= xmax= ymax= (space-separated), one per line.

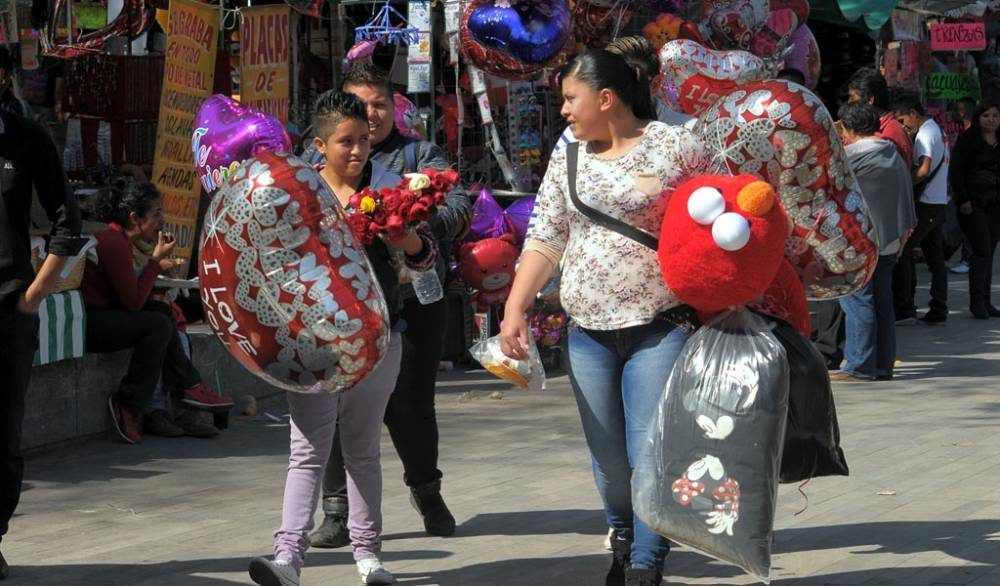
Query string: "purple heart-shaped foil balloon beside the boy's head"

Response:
xmin=191 ymin=94 xmax=292 ymax=196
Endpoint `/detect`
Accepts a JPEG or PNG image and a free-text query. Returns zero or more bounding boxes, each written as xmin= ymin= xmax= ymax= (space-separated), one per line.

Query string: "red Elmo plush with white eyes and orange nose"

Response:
xmin=659 ymin=175 xmax=810 ymax=337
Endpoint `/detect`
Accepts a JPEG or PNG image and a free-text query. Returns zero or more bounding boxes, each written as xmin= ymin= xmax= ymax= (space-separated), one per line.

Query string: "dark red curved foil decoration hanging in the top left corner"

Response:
xmin=42 ymin=0 xmax=153 ymax=58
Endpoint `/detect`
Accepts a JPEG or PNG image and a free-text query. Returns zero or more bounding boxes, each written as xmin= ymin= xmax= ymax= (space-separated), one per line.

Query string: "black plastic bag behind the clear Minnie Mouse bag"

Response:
xmin=767 ymin=317 xmax=849 ymax=483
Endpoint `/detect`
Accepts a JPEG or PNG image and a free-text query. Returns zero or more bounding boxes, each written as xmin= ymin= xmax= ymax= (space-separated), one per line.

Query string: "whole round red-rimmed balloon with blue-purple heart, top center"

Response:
xmin=460 ymin=0 xmax=572 ymax=79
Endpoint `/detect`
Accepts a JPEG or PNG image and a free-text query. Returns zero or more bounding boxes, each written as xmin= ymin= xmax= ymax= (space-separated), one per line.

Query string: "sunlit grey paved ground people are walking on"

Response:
xmin=3 ymin=266 xmax=1000 ymax=586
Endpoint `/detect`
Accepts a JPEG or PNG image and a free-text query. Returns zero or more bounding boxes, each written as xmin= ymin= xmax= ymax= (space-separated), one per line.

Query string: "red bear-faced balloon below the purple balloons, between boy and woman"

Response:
xmin=458 ymin=234 xmax=521 ymax=309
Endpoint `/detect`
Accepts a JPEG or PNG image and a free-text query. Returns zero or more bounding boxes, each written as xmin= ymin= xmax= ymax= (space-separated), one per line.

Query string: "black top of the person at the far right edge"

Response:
xmin=948 ymin=128 xmax=1000 ymax=207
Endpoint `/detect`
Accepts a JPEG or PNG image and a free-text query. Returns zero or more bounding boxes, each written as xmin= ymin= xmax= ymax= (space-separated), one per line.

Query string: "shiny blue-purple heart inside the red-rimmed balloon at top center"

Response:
xmin=468 ymin=0 xmax=572 ymax=65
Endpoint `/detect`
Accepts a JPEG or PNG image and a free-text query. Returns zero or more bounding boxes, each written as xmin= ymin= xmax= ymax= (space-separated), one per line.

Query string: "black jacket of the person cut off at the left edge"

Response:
xmin=0 ymin=111 xmax=83 ymax=314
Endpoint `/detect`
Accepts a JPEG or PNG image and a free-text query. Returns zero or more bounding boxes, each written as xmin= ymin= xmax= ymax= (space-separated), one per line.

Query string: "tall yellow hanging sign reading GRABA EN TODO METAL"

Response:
xmin=153 ymin=0 xmax=219 ymax=272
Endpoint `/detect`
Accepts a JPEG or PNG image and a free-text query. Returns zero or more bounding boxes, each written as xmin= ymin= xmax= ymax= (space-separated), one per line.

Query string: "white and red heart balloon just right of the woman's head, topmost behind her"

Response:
xmin=658 ymin=39 xmax=768 ymax=116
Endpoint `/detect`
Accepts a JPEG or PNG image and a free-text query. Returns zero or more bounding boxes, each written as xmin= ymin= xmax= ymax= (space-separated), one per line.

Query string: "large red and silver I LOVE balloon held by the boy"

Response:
xmin=198 ymin=152 xmax=389 ymax=392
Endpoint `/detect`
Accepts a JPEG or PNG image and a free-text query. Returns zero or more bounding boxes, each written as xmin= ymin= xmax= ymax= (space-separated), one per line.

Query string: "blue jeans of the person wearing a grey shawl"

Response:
xmin=840 ymin=254 xmax=896 ymax=378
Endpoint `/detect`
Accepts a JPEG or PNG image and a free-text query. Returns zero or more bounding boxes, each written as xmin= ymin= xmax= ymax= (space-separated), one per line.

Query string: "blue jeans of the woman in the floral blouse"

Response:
xmin=569 ymin=320 xmax=687 ymax=569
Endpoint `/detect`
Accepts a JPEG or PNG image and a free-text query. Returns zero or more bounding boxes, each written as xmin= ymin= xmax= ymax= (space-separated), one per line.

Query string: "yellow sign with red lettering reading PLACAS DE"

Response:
xmin=240 ymin=4 xmax=292 ymax=124
